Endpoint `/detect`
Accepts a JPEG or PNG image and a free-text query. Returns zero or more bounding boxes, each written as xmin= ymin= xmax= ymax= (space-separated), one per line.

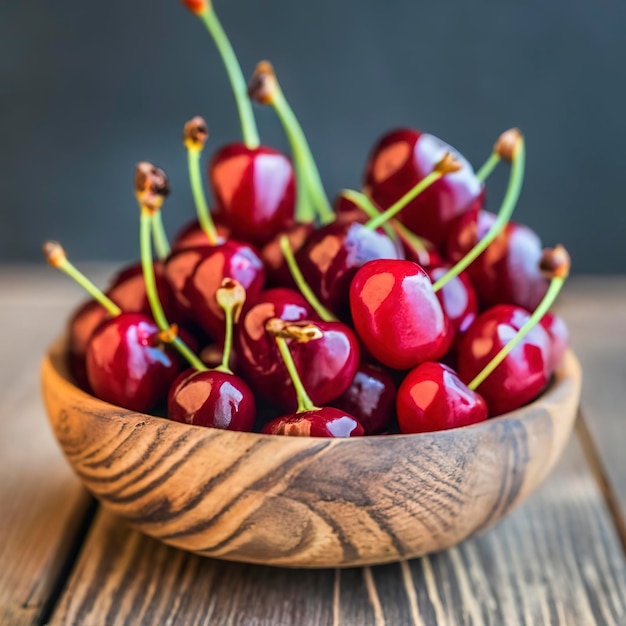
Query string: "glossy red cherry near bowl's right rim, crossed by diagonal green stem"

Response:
xmin=458 ymin=304 xmax=552 ymax=416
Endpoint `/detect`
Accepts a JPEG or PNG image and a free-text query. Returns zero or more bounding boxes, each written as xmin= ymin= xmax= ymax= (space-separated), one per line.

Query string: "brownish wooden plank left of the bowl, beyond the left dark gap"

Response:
xmin=0 ymin=267 xmax=111 ymax=626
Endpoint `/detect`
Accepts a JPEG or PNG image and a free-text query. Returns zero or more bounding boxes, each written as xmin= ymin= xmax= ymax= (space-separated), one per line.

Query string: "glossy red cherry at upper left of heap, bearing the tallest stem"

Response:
xmin=209 ymin=143 xmax=296 ymax=245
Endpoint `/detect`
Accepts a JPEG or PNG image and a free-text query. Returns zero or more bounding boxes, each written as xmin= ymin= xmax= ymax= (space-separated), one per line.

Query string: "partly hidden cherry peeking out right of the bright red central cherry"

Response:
xmin=425 ymin=263 xmax=478 ymax=344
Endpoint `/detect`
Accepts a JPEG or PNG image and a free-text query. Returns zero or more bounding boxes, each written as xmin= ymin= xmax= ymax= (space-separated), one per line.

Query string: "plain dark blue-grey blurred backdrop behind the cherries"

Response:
xmin=0 ymin=0 xmax=626 ymax=273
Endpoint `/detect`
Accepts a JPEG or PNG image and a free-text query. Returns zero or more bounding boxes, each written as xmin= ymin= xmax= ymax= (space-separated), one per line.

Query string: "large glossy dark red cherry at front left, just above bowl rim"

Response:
xmin=86 ymin=313 xmax=182 ymax=411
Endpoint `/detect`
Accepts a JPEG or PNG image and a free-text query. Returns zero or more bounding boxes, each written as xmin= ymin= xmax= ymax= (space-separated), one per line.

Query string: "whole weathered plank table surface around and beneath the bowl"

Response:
xmin=0 ymin=267 xmax=626 ymax=626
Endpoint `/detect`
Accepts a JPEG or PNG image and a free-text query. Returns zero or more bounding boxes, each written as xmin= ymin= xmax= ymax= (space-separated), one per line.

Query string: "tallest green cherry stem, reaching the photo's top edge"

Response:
xmin=199 ymin=2 xmax=261 ymax=150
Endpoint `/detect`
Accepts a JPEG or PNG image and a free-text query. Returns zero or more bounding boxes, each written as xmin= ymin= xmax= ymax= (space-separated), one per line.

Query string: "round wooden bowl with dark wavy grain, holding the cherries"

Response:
xmin=42 ymin=341 xmax=581 ymax=567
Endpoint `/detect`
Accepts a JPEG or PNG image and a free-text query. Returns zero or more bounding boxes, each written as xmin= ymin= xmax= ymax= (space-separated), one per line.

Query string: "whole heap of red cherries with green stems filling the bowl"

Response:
xmin=44 ymin=0 xmax=569 ymax=437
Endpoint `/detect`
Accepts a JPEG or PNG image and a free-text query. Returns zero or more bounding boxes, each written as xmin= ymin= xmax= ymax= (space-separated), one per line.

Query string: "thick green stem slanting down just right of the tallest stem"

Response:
xmin=272 ymin=86 xmax=335 ymax=224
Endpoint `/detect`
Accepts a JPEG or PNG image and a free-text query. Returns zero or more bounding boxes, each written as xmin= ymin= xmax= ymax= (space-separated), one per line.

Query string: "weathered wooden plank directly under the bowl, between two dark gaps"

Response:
xmin=51 ymin=432 xmax=626 ymax=626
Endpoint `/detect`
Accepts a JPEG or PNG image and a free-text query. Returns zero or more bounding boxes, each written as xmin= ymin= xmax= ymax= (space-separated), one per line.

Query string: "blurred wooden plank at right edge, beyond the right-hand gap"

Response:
xmin=560 ymin=277 xmax=626 ymax=545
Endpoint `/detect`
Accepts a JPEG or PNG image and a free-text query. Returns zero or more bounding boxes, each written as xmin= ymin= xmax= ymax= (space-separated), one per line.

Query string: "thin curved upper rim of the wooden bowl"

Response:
xmin=41 ymin=334 xmax=582 ymax=445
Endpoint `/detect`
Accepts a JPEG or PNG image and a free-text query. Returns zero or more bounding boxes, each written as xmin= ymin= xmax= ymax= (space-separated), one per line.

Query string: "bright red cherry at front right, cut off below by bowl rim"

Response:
xmin=396 ymin=362 xmax=488 ymax=434
